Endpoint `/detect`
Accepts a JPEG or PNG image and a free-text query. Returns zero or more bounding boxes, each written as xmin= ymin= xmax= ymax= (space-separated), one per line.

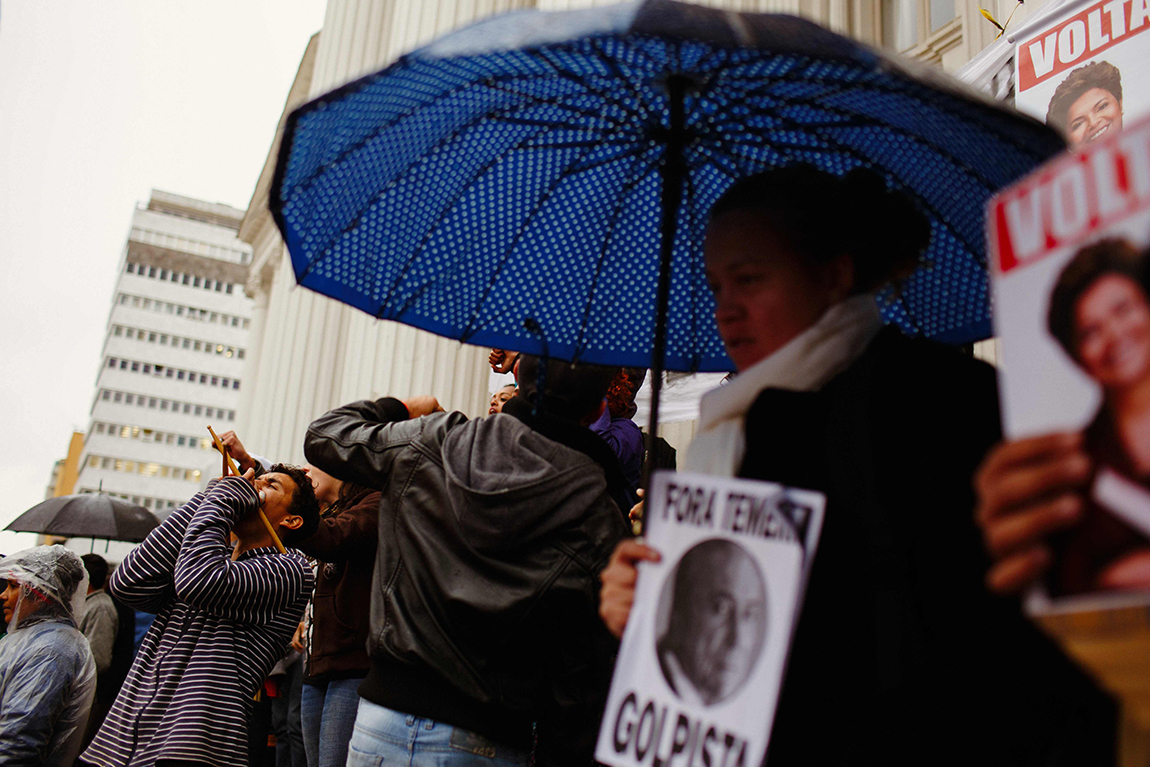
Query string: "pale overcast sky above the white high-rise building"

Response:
xmin=0 ymin=0 xmax=325 ymax=553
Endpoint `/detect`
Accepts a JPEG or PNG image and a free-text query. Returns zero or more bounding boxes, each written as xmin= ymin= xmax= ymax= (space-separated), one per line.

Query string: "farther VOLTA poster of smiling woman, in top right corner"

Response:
xmin=1013 ymin=0 xmax=1150 ymax=148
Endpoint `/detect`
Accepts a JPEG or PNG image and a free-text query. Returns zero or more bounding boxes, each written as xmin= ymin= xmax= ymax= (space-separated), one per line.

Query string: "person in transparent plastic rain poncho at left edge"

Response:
xmin=0 ymin=546 xmax=95 ymax=767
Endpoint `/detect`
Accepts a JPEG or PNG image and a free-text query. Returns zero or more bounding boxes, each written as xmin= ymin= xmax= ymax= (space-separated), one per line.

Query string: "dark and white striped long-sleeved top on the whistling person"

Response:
xmin=82 ymin=477 xmax=314 ymax=767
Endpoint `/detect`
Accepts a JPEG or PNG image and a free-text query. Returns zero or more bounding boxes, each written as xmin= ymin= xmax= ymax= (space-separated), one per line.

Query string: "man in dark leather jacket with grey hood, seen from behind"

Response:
xmin=305 ymin=355 xmax=633 ymax=765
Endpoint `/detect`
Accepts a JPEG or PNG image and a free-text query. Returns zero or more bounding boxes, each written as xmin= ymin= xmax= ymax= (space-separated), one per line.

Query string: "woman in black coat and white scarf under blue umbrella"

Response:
xmin=600 ymin=166 xmax=1114 ymax=767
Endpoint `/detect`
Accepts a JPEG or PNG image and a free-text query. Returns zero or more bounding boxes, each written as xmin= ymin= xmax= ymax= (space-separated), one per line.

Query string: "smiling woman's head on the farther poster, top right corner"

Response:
xmin=1047 ymin=61 xmax=1122 ymax=147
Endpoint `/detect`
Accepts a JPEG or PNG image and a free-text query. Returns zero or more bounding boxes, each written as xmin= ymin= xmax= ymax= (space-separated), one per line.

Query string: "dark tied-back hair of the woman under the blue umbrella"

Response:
xmin=711 ymin=163 xmax=930 ymax=293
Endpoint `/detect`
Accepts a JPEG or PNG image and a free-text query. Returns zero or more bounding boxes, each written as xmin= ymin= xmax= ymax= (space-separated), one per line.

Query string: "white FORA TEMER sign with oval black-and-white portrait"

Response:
xmin=596 ymin=471 xmax=826 ymax=767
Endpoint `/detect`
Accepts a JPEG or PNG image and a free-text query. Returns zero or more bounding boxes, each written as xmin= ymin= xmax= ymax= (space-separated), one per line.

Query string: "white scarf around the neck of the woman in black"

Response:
xmin=684 ymin=293 xmax=882 ymax=477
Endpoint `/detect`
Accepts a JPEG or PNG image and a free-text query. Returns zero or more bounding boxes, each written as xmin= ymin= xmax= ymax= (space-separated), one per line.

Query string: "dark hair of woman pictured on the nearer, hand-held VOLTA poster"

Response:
xmin=1047 ymin=237 xmax=1145 ymax=361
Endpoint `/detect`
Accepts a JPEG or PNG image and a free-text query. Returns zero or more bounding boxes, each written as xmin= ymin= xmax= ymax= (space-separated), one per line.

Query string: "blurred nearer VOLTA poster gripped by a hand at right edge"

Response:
xmin=988 ymin=112 xmax=1150 ymax=611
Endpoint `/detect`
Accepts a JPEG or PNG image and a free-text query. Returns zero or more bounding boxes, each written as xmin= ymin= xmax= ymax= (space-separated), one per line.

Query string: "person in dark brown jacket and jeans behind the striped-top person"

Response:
xmin=299 ymin=466 xmax=380 ymax=767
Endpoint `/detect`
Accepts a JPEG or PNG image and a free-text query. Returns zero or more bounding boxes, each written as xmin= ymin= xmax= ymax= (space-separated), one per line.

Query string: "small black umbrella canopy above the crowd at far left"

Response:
xmin=5 ymin=493 xmax=160 ymax=543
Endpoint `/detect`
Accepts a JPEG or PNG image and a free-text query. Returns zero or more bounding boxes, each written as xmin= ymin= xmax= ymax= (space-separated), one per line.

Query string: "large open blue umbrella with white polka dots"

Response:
xmin=271 ymin=0 xmax=1064 ymax=425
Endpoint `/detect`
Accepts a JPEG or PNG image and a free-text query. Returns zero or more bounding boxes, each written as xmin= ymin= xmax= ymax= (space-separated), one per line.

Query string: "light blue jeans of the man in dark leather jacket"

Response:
xmin=347 ymin=698 xmax=528 ymax=767
